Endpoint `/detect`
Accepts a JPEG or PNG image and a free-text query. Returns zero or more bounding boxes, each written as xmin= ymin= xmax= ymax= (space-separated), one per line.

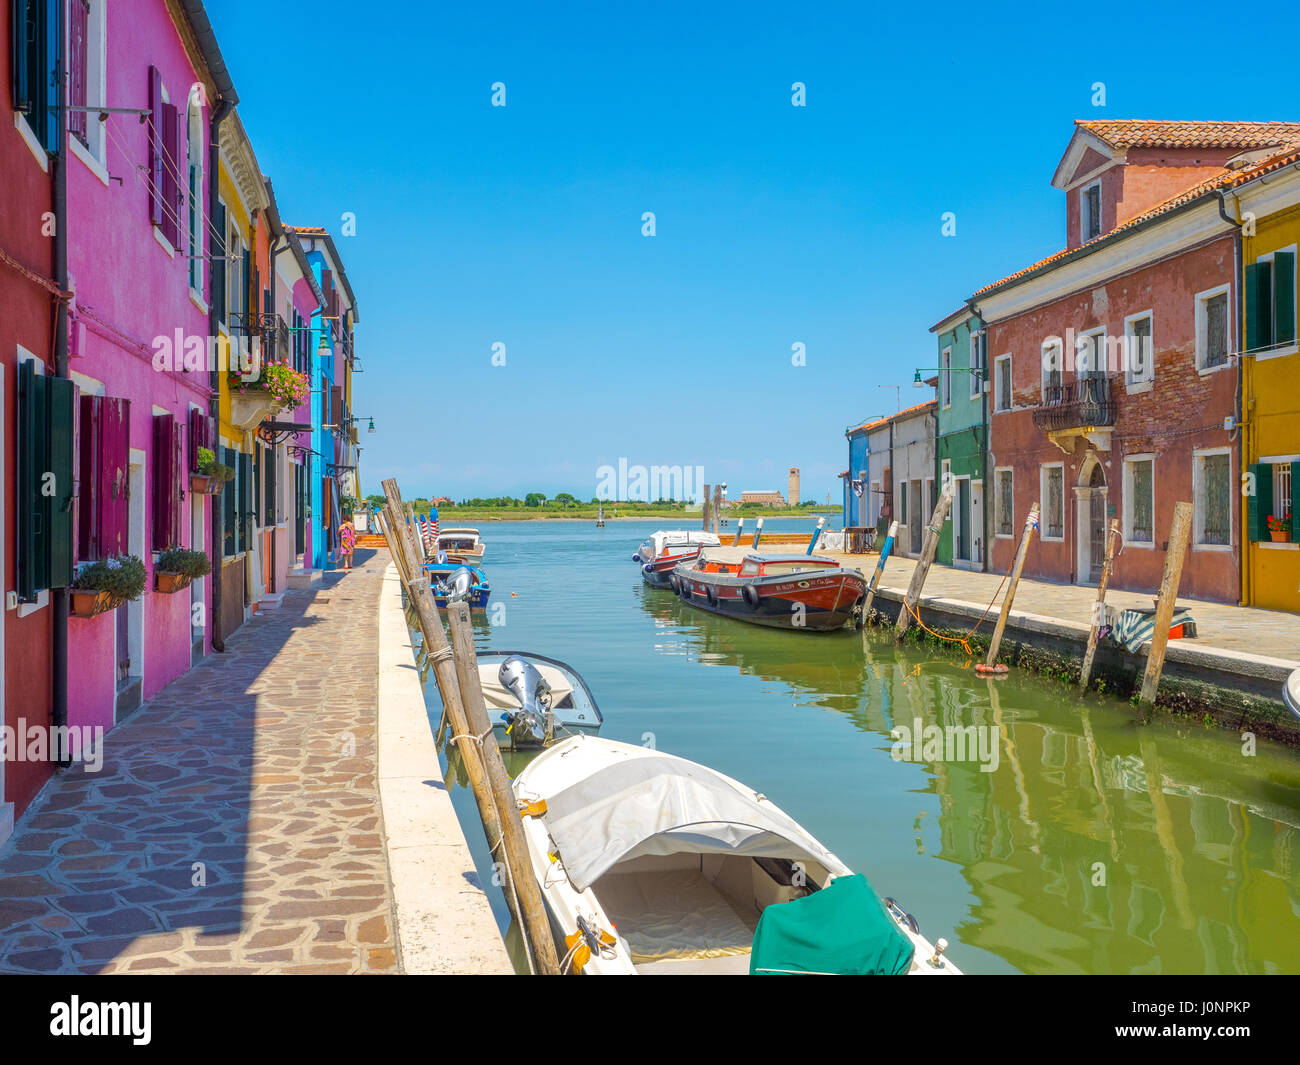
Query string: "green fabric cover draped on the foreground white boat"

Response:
xmin=749 ymin=873 xmax=914 ymax=977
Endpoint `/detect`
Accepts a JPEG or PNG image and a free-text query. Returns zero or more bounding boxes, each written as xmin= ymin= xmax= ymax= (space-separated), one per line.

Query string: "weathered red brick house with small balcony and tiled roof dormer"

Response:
xmin=971 ymin=121 xmax=1300 ymax=602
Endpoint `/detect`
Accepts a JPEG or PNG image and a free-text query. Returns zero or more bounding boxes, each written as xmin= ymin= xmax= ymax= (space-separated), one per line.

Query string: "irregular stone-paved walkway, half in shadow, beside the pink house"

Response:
xmin=0 ymin=551 xmax=398 ymax=973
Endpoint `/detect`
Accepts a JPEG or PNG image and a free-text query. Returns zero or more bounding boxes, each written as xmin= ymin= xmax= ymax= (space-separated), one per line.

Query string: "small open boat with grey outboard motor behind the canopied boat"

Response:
xmin=478 ymin=651 xmax=605 ymax=748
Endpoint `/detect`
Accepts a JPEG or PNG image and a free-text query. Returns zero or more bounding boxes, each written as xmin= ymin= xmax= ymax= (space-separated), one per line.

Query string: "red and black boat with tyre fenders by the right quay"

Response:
xmin=672 ymin=554 xmax=867 ymax=632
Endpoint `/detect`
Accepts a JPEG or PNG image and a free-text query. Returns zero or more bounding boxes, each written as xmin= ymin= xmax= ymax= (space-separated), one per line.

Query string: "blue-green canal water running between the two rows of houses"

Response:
xmin=416 ymin=519 xmax=1300 ymax=974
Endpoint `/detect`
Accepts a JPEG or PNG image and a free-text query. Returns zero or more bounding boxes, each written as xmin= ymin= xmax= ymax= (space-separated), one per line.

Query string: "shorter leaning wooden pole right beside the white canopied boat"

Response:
xmin=447 ymin=602 xmax=559 ymax=975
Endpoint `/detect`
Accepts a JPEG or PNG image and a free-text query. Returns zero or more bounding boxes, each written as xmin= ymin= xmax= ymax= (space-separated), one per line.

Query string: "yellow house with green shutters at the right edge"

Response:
xmin=1231 ymin=153 xmax=1300 ymax=612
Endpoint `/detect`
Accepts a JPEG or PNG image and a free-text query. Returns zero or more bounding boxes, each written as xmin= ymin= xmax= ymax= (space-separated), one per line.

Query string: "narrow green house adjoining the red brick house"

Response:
xmin=930 ymin=307 xmax=989 ymax=570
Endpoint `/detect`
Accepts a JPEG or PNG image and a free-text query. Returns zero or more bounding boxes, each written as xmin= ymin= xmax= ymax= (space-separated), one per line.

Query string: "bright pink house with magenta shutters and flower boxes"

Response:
xmin=66 ymin=0 xmax=234 ymax=728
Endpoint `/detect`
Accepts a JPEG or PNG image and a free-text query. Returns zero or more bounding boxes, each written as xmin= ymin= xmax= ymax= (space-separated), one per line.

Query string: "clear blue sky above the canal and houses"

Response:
xmin=208 ymin=0 xmax=1300 ymax=501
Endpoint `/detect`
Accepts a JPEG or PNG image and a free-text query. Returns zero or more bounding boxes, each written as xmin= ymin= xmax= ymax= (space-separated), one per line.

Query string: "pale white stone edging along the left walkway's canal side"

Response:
xmin=378 ymin=562 xmax=515 ymax=974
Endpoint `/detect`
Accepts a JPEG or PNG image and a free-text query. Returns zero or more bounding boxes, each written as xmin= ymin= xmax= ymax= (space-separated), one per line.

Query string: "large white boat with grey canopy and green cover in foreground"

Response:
xmin=514 ymin=736 xmax=959 ymax=975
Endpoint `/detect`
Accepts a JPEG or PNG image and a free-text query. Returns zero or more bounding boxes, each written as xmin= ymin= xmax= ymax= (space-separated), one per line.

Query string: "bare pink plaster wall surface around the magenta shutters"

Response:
xmin=66 ymin=0 xmax=212 ymax=726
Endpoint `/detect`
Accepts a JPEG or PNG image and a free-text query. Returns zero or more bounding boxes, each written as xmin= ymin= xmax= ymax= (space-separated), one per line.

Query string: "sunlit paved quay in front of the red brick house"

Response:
xmin=820 ymin=551 xmax=1300 ymax=664
